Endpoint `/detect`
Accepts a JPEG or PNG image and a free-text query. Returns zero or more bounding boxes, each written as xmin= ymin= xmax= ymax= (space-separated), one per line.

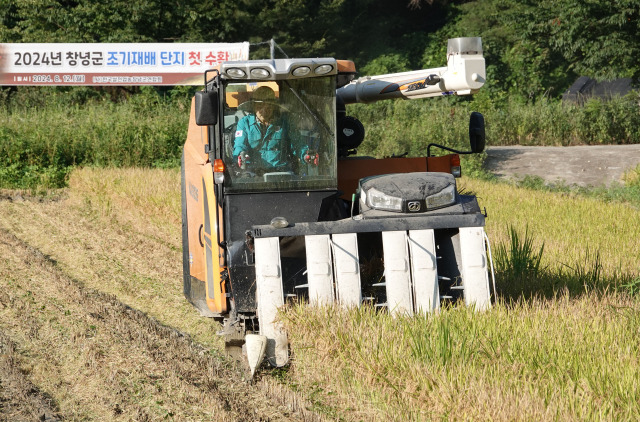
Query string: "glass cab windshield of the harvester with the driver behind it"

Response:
xmin=223 ymin=77 xmax=337 ymax=192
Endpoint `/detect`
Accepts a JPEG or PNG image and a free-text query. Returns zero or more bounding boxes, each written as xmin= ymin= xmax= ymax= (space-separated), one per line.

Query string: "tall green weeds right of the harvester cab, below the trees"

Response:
xmin=347 ymin=92 xmax=640 ymax=159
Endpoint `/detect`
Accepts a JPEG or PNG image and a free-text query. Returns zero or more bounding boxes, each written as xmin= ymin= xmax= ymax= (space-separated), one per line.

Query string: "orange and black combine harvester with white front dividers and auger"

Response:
xmin=182 ymin=38 xmax=491 ymax=371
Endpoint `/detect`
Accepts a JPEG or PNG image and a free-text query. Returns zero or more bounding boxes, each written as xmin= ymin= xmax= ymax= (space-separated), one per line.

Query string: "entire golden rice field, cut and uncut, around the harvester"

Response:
xmin=0 ymin=168 xmax=640 ymax=421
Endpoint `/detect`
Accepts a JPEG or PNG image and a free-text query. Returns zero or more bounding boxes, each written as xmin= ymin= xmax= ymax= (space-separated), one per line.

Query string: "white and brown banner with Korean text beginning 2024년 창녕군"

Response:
xmin=0 ymin=42 xmax=249 ymax=86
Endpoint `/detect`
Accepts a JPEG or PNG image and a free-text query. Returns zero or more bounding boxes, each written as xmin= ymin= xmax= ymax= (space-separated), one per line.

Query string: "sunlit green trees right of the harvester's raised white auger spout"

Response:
xmin=442 ymin=0 xmax=640 ymax=100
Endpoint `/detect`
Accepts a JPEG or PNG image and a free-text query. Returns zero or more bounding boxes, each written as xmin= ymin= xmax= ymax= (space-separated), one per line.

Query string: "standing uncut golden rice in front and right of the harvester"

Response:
xmin=283 ymin=179 xmax=640 ymax=421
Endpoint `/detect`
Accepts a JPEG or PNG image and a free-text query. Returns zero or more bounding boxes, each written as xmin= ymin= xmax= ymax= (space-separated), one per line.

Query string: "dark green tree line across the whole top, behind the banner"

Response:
xmin=0 ymin=0 xmax=640 ymax=101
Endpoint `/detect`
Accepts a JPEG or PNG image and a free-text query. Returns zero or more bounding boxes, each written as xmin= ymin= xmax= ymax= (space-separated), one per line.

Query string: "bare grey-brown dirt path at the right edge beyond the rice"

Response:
xmin=485 ymin=145 xmax=640 ymax=186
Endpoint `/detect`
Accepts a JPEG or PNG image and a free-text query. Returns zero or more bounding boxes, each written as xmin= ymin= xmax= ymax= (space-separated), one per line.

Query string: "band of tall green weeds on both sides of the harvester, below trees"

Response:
xmin=0 ymin=87 xmax=640 ymax=190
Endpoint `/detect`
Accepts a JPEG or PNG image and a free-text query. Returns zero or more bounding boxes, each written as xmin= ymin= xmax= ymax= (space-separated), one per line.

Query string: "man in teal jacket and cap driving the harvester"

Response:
xmin=233 ymin=86 xmax=318 ymax=173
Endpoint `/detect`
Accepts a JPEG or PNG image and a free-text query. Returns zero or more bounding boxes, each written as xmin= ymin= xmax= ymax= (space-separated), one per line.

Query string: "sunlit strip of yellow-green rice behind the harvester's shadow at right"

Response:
xmin=460 ymin=178 xmax=640 ymax=275
